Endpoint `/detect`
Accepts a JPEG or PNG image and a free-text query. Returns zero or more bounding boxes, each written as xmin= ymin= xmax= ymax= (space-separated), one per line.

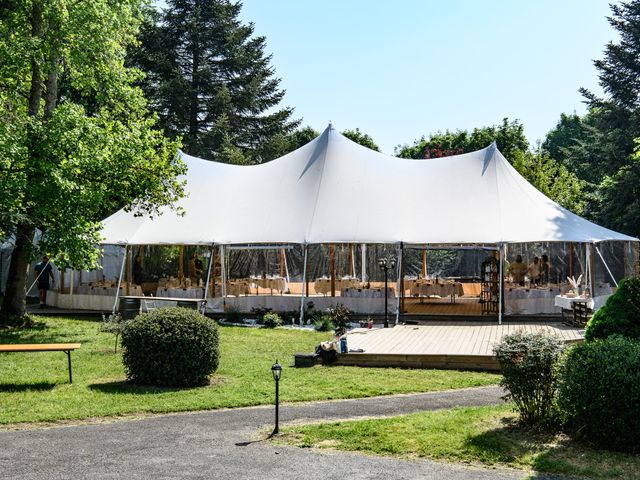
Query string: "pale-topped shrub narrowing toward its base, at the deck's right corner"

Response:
xmin=493 ymin=331 xmax=563 ymax=427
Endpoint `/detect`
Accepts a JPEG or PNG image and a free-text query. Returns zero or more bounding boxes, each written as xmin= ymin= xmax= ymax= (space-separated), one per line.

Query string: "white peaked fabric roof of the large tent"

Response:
xmin=102 ymin=126 xmax=637 ymax=245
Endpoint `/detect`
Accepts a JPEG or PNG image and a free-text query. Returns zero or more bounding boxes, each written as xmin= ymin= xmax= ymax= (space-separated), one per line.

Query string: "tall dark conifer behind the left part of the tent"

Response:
xmin=130 ymin=0 xmax=299 ymax=164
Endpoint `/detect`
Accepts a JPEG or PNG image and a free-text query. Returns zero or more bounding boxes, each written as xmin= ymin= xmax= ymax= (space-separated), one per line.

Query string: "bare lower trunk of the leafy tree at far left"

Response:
xmin=0 ymin=226 xmax=35 ymax=319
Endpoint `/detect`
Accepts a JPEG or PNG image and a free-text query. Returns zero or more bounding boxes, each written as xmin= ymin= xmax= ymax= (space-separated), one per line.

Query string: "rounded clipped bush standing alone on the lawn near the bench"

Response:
xmin=122 ymin=307 xmax=220 ymax=387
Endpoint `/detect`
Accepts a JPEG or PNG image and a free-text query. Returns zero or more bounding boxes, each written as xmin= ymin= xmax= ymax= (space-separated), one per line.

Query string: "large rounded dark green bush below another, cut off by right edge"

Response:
xmin=558 ymin=335 xmax=640 ymax=452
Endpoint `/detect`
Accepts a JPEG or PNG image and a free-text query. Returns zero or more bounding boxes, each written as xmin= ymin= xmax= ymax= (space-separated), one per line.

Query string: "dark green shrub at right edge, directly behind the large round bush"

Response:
xmin=584 ymin=278 xmax=640 ymax=341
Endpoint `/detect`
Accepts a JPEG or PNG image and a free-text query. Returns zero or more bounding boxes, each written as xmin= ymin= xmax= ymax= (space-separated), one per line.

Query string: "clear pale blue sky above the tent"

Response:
xmin=231 ymin=0 xmax=617 ymax=154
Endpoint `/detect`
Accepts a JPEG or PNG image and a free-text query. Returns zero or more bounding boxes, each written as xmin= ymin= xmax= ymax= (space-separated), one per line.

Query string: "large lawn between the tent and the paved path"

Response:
xmin=0 ymin=317 xmax=499 ymax=424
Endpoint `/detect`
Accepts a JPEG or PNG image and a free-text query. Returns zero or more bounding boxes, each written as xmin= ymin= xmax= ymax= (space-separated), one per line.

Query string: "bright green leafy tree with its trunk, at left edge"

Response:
xmin=0 ymin=0 xmax=184 ymax=321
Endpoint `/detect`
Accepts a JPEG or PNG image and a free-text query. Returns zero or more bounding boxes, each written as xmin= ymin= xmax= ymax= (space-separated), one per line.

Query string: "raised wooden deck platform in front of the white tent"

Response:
xmin=338 ymin=321 xmax=584 ymax=371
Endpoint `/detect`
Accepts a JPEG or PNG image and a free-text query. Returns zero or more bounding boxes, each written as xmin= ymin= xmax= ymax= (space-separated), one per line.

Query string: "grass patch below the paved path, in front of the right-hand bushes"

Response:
xmin=281 ymin=405 xmax=640 ymax=480
